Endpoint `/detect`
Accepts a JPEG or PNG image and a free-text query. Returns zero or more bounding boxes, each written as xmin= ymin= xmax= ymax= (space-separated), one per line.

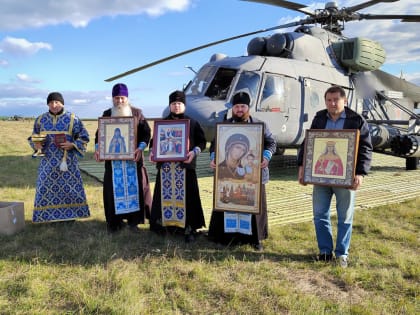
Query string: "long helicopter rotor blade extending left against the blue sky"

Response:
xmin=105 ymin=18 xmax=308 ymax=82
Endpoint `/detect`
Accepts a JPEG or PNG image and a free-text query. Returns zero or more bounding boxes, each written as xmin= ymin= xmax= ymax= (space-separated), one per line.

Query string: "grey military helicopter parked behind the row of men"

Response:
xmin=105 ymin=0 xmax=420 ymax=170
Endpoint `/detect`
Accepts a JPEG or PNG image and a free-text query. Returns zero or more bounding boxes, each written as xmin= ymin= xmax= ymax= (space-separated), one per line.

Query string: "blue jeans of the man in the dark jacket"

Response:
xmin=312 ymin=185 xmax=356 ymax=257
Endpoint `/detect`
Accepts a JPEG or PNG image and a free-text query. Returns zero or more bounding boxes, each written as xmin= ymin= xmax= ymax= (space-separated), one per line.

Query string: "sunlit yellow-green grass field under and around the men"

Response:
xmin=0 ymin=121 xmax=420 ymax=315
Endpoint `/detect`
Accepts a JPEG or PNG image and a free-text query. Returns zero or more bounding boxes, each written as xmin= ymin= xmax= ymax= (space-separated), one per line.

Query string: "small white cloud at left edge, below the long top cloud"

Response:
xmin=0 ymin=36 xmax=52 ymax=55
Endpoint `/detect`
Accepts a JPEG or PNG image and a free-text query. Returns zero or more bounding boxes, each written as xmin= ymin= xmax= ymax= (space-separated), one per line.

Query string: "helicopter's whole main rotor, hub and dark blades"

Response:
xmin=105 ymin=0 xmax=420 ymax=82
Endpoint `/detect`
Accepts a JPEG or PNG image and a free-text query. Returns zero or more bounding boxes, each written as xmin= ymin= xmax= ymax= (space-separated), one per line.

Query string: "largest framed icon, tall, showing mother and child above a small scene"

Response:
xmin=213 ymin=123 xmax=264 ymax=214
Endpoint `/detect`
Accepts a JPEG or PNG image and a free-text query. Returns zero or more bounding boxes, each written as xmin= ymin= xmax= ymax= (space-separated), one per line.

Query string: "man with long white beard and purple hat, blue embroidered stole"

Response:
xmin=95 ymin=83 xmax=152 ymax=233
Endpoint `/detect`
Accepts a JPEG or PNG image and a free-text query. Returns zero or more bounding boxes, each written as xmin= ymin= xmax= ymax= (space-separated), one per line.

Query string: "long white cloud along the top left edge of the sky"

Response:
xmin=0 ymin=0 xmax=191 ymax=30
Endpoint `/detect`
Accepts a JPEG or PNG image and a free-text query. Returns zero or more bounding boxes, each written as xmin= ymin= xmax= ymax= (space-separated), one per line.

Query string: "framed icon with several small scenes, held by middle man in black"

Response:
xmin=152 ymin=119 xmax=190 ymax=162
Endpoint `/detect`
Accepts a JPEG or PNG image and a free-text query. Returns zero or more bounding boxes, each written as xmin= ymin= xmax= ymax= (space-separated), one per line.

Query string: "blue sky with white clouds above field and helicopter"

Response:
xmin=0 ymin=0 xmax=420 ymax=118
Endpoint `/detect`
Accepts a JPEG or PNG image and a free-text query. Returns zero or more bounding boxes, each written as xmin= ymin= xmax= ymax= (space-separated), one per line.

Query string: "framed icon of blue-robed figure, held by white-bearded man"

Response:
xmin=98 ymin=117 xmax=136 ymax=160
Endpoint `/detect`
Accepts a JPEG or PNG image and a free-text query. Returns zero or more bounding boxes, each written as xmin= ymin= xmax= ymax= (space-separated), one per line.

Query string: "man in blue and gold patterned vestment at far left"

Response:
xmin=28 ymin=92 xmax=90 ymax=223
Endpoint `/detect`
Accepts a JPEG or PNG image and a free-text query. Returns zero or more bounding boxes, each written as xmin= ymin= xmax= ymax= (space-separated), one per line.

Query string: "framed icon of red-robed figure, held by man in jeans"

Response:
xmin=303 ymin=129 xmax=359 ymax=188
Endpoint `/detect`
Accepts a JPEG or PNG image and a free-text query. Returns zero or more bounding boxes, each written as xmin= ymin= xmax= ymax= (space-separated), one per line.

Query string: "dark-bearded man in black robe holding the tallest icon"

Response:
xmin=209 ymin=92 xmax=276 ymax=251
